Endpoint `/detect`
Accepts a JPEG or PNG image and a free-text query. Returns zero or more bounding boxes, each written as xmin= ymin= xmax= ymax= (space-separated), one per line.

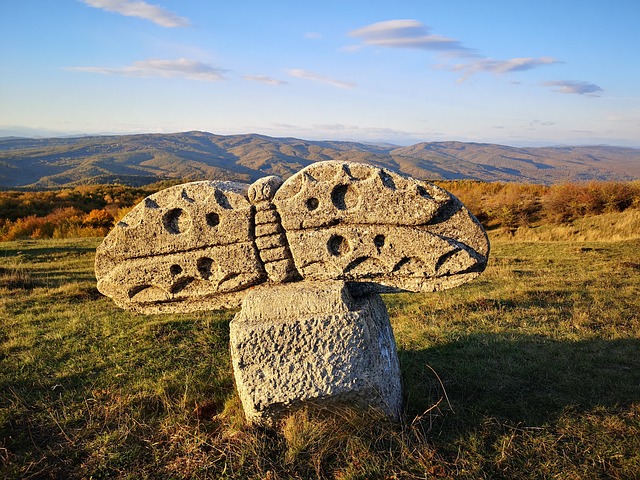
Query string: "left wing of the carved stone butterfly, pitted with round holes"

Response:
xmin=95 ymin=181 xmax=267 ymax=313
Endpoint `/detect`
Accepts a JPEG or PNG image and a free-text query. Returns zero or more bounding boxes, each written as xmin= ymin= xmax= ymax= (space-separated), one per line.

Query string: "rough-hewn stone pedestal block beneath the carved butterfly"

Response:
xmin=230 ymin=281 xmax=402 ymax=423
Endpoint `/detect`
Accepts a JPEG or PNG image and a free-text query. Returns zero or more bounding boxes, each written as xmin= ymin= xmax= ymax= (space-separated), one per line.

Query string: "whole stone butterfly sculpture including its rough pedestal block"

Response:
xmin=96 ymin=161 xmax=489 ymax=422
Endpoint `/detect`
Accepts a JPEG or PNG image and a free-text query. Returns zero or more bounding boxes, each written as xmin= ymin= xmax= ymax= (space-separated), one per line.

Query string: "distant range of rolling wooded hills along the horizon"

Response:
xmin=0 ymin=132 xmax=640 ymax=189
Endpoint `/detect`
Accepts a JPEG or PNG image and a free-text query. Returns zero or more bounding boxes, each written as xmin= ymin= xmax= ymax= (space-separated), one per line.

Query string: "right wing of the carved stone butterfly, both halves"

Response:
xmin=274 ymin=161 xmax=489 ymax=292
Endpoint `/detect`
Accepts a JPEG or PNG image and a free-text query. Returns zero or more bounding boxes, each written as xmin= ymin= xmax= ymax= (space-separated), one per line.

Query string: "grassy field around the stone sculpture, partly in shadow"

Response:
xmin=0 ymin=234 xmax=640 ymax=480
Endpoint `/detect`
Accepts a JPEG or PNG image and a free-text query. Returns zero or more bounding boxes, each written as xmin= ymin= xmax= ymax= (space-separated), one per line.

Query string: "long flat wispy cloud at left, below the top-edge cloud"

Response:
xmin=67 ymin=58 xmax=226 ymax=82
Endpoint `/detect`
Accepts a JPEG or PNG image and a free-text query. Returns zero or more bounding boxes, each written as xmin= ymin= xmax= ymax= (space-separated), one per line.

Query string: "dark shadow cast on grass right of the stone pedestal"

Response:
xmin=399 ymin=333 xmax=640 ymax=427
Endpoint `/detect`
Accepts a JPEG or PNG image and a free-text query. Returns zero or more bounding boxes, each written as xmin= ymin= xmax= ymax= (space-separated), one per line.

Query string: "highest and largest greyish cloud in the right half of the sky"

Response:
xmin=349 ymin=20 xmax=473 ymax=55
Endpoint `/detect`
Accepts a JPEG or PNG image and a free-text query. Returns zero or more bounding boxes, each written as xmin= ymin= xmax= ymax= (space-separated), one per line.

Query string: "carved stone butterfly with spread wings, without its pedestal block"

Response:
xmin=96 ymin=161 xmax=489 ymax=313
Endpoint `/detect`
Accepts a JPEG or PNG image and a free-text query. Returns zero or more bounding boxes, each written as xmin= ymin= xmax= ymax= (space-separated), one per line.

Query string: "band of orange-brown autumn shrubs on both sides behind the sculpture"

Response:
xmin=0 ymin=180 xmax=640 ymax=241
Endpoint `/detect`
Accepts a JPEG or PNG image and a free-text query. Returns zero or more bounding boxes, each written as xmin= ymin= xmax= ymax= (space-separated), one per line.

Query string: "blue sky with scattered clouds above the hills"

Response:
xmin=0 ymin=0 xmax=640 ymax=146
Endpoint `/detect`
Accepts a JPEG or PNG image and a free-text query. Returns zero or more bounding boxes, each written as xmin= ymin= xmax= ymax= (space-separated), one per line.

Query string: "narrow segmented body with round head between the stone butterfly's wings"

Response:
xmin=248 ymin=175 xmax=301 ymax=283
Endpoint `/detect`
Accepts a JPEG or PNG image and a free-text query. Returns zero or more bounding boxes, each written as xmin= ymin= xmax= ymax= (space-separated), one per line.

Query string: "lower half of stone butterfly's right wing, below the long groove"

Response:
xmin=287 ymin=225 xmax=479 ymax=292
